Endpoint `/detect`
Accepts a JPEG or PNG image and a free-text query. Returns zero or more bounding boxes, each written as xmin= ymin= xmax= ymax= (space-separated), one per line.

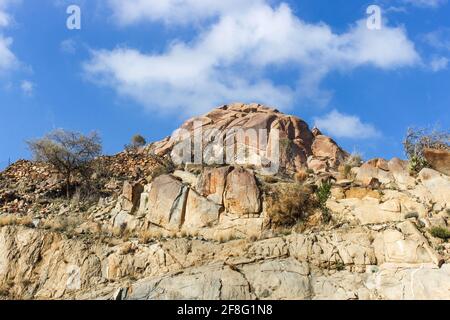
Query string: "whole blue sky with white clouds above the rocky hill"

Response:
xmin=0 ymin=0 xmax=450 ymax=168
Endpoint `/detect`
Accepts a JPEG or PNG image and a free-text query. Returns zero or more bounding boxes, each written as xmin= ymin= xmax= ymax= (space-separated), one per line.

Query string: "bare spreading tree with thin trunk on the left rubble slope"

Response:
xmin=27 ymin=129 xmax=102 ymax=198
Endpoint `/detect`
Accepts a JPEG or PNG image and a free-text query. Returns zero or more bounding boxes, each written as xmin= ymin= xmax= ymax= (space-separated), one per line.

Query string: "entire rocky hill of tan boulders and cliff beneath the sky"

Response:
xmin=0 ymin=104 xmax=450 ymax=299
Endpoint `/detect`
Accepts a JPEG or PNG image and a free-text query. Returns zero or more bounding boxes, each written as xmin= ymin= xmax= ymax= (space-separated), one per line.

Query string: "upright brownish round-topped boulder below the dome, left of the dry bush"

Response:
xmin=224 ymin=168 xmax=261 ymax=215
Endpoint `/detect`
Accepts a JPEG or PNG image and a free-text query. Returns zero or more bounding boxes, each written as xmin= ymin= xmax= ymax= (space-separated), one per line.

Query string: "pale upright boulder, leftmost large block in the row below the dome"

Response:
xmin=146 ymin=175 xmax=188 ymax=230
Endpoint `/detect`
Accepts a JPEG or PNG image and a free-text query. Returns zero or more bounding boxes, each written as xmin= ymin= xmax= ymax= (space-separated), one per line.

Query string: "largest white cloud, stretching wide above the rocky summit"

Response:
xmin=84 ymin=0 xmax=420 ymax=114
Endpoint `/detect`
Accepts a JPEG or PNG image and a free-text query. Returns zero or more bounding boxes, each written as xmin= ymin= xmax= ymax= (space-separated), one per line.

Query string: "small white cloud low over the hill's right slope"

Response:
xmin=314 ymin=110 xmax=381 ymax=139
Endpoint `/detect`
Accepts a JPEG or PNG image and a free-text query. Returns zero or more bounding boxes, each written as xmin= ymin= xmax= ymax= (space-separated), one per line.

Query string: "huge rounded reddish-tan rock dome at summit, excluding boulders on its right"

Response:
xmin=157 ymin=103 xmax=314 ymax=172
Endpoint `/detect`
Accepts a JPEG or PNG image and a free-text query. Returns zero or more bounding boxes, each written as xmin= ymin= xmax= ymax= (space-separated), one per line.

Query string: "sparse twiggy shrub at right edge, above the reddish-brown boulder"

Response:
xmin=403 ymin=128 xmax=450 ymax=173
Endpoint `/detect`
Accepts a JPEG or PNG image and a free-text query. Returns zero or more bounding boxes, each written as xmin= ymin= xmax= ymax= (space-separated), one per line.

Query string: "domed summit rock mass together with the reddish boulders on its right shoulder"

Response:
xmin=149 ymin=103 xmax=348 ymax=172
